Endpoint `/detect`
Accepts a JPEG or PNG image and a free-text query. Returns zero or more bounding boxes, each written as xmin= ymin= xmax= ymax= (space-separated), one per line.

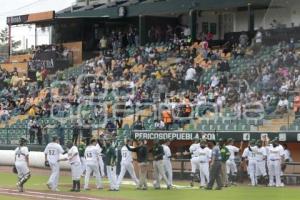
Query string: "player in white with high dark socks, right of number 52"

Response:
xmin=67 ymin=142 xmax=81 ymax=192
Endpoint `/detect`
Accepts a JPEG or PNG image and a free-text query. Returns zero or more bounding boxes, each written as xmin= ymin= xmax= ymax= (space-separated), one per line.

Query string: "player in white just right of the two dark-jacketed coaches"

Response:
xmin=162 ymin=140 xmax=173 ymax=186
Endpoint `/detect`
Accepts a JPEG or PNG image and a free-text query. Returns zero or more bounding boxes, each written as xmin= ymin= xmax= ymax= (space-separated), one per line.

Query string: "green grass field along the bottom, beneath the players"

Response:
xmin=0 ymin=173 xmax=300 ymax=200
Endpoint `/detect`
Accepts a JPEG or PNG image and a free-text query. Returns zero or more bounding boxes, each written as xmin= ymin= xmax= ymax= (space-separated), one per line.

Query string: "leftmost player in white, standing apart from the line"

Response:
xmin=15 ymin=138 xmax=30 ymax=192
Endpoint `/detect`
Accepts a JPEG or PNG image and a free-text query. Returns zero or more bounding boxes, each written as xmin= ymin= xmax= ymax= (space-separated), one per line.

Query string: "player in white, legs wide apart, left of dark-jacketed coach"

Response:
xmin=117 ymin=140 xmax=139 ymax=188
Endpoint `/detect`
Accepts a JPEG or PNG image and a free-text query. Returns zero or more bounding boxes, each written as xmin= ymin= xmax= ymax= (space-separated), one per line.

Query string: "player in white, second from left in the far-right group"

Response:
xmin=255 ymin=140 xmax=267 ymax=184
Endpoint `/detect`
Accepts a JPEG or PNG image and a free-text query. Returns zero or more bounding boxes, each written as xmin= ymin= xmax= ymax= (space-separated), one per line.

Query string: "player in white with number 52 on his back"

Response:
xmin=44 ymin=137 xmax=64 ymax=191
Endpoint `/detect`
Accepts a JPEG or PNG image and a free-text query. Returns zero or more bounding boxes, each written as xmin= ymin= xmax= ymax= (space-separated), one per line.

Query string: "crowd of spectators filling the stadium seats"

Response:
xmin=0 ymin=23 xmax=300 ymax=143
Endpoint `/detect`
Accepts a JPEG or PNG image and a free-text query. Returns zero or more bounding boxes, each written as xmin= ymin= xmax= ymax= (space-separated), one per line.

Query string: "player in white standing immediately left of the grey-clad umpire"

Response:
xmin=196 ymin=140 xmax=211 ymax=188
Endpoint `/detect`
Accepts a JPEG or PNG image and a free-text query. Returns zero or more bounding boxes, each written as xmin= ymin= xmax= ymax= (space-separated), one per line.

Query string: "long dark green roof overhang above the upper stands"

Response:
xmin=56 ymin=0 xmax=271 ymax=19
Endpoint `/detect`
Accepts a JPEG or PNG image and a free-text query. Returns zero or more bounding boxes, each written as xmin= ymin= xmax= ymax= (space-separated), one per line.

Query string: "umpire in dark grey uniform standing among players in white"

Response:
xmin=206 ymin=141 xmax=222 ymax=190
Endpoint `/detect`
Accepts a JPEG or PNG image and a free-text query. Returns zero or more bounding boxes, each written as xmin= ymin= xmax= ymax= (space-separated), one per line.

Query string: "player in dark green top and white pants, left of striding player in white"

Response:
xmin=105 ymin=140 xmax=119 ymax=191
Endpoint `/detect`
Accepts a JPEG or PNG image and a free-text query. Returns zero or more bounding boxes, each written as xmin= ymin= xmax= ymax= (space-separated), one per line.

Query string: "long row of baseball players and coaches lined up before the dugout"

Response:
xmin=14 ymin=134 xmax=290 ymax=192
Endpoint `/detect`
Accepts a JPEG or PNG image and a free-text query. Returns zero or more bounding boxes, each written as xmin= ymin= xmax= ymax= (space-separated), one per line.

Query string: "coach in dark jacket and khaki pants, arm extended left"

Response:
xmin=126 ymin=140 xmax=148 ymax=190
